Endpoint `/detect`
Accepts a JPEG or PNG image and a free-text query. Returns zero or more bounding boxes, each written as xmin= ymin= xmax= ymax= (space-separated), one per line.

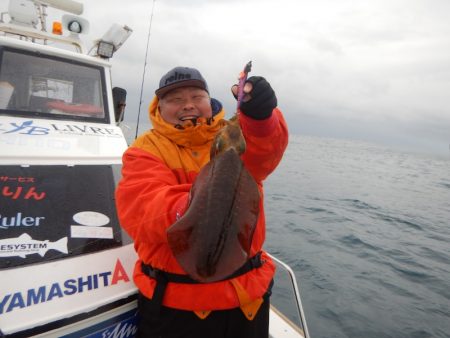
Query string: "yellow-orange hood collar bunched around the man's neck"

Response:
xmin=149 ymin=96 xmax=225 ymax=147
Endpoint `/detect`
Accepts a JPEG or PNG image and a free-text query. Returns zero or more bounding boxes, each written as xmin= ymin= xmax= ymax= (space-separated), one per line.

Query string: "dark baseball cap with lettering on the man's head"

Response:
xmin=155 ymin=67 xmax=209 ymax=98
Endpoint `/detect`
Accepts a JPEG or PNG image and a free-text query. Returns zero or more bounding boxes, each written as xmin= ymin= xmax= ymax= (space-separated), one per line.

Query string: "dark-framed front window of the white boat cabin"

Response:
xmin=0 ymin=47 xmax=109 ymax=123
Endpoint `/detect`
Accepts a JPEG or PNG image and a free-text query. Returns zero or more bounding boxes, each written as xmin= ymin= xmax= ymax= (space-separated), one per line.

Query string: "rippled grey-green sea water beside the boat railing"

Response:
xmin=265 ymin=136 xmax=450 ymax=338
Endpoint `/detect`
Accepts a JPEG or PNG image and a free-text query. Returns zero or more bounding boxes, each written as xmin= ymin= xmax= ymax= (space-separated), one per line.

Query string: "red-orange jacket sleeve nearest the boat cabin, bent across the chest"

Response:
xmin=116 ymin=147 xmax=192 ymax=261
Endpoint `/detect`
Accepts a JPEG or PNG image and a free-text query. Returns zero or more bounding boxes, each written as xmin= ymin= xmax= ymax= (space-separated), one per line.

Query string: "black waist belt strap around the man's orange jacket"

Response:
xmin=141 ymin=252 xmax=264 ymax=314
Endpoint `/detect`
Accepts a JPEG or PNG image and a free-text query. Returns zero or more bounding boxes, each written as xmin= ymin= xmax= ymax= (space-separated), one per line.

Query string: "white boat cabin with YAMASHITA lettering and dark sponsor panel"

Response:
xmin=0 ymin=0 xmax=140 ymax=337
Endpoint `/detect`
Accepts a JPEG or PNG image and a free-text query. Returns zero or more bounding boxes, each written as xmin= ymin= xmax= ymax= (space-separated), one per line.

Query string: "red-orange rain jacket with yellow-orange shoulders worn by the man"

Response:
xmin=116 ymin=97 xmax=288 ymax=312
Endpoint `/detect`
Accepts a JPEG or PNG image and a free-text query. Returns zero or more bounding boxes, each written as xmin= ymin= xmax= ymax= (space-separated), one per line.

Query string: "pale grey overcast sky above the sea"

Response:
xmin=3 ymin=0 xmax=450 ymax=154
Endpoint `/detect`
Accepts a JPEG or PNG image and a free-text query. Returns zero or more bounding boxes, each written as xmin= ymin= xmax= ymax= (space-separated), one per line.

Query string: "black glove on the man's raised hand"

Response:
xmin=241 ymin=76 xmax=277 ymax=120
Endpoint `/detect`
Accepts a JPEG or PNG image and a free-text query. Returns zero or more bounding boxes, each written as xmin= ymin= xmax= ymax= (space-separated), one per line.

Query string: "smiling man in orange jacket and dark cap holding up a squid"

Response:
xmin=116 ymin=67 xmax=288 ymax=338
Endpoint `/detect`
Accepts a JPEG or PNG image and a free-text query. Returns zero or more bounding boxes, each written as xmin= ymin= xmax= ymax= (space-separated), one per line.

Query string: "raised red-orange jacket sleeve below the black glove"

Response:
xmin=239 ymin=108 xmax=288 ymax=183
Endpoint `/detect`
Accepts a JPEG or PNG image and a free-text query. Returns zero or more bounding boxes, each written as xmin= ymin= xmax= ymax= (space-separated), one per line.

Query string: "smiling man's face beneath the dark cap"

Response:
xmin=159 ymin=87 xmax=212 ymax=125
